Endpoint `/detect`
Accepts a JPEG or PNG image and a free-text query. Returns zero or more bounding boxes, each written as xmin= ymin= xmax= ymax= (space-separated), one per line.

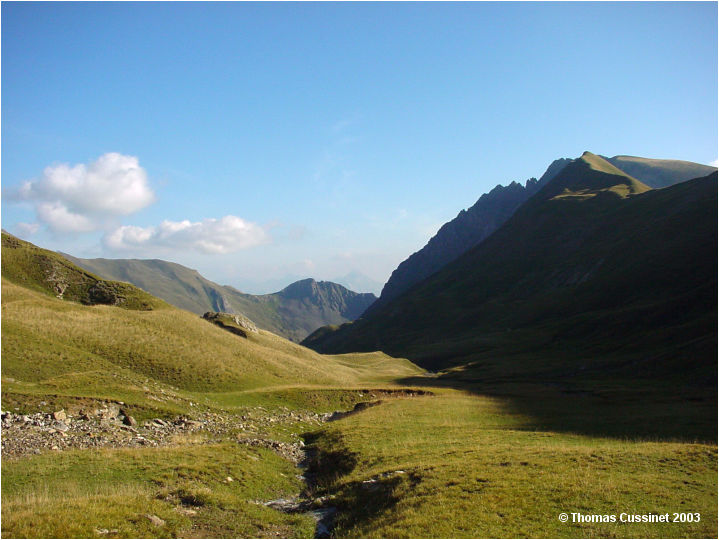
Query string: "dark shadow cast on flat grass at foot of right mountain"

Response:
xmin=398 ymin=362 xmax=717 ymax=443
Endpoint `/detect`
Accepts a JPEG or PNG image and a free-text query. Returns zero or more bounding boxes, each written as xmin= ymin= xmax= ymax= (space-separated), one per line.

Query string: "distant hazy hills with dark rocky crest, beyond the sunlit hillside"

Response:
xmin=66 ymin=255 xmax=376 ymax=342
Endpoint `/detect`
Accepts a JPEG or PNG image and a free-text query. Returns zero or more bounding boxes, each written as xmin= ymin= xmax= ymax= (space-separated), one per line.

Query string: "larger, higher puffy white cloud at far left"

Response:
xmin=11 ymin=152 xmax=155 ymax=232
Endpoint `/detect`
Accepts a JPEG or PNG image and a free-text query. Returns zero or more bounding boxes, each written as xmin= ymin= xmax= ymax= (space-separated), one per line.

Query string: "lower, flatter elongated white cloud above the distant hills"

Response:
xmin=104 ymin=216 xmax=270 ymax=254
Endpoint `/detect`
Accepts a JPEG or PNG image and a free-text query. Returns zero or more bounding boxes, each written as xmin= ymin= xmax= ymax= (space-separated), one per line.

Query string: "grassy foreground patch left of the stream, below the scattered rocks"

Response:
xmin=2 ymin=441 xmax=315 ymax=538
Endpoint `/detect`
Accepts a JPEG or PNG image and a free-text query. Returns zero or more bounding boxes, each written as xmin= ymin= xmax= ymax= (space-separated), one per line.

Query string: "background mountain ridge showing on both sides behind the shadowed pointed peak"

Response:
xmin=368 ymin=156 xmax=716 ymax=313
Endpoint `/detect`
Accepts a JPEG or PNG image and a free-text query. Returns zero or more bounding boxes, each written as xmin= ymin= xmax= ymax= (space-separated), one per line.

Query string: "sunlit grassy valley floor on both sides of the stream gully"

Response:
xmin=2 ymin=381 xmax=717 ymax=538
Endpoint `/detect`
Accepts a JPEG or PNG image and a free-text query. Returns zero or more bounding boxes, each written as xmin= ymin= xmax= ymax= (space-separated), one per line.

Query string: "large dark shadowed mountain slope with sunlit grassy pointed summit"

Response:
xmin=304 ymin=153 xmax=717 ymax=384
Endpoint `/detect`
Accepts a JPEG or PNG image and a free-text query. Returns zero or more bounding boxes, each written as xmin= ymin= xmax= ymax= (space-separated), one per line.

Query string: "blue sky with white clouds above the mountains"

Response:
xmin=2 ymin=2 xmax=717 ymax=293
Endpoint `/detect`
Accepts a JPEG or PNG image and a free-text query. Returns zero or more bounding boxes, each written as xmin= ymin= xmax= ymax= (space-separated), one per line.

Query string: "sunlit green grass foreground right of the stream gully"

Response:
xmin=306 ymin=391 xmax=717 ymax=538
